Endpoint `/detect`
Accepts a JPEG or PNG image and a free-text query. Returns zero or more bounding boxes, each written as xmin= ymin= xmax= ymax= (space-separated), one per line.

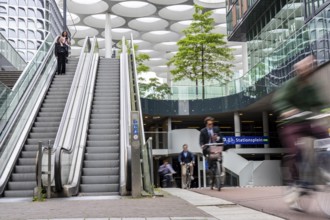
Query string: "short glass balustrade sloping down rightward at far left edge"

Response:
xmin=0 ymin=33 xmax=26 ymax=71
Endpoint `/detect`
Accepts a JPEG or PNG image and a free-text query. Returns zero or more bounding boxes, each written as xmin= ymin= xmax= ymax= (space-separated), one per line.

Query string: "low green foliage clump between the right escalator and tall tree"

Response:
xmin=139 ymin=77 xmax=171 ymax=99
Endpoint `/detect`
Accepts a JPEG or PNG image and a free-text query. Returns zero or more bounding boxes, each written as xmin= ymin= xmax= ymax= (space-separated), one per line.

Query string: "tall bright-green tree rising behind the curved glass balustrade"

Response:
xmin=168 ymin=5 xmax=234 ymax=99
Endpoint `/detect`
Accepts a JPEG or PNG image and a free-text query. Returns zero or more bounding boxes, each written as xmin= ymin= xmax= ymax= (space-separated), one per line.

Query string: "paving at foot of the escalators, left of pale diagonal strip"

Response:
xmin=0 ymin=195 xmax=214 ymax=220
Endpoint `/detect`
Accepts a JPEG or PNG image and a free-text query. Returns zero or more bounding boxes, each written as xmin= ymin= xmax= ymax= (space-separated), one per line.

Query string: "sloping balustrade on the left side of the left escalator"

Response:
xmin=0 ymin=35 xmax=56 ymax=195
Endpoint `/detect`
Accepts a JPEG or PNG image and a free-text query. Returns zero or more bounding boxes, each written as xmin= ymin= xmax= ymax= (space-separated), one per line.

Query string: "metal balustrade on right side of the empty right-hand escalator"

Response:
xmin=119 ymin=37 xmax=131 ymax=195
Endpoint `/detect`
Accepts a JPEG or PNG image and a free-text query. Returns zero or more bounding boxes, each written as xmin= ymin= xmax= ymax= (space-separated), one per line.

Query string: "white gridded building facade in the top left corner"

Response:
xmin=0 ymin=0 xmax=63 ymax=61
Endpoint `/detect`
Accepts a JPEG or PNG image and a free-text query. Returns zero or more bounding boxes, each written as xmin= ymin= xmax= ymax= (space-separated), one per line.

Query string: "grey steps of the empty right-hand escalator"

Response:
xmin=80 ymin=59 xmax=120 ymax=195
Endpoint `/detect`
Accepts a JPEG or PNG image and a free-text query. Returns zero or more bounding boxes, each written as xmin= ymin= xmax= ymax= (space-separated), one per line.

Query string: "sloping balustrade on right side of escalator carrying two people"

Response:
xmin=53 ymin=37 xmax=91 ymax=192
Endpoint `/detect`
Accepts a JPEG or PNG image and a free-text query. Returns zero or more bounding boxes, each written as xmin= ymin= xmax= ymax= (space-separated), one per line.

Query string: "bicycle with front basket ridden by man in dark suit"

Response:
xmin=205 ymin=143 xmax=224 ymax=191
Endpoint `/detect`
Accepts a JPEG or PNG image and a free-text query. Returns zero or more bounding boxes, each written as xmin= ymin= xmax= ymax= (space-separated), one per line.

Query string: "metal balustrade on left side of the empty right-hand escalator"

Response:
xmin=62 ymin=37 xmax=99 ymax=196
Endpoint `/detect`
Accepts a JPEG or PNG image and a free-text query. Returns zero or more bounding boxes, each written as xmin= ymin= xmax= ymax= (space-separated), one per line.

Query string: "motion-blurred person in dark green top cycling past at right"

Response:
xmin=273 ymin=55 xmax=328 ymax=209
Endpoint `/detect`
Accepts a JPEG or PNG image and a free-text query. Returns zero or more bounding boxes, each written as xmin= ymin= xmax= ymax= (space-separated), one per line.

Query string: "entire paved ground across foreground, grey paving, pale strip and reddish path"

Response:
xmin=0 ymin=187 xmax=328 ymax=220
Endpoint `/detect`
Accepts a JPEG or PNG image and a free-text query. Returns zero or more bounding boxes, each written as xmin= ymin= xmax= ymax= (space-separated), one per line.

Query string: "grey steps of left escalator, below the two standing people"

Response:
xmin=4 ymin=58 xmax=78 ymax=197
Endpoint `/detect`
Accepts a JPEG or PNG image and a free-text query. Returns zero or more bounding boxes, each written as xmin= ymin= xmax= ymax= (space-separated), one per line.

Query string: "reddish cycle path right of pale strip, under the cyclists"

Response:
xmin=193 ymin=187 xmax=329 ymax=220
